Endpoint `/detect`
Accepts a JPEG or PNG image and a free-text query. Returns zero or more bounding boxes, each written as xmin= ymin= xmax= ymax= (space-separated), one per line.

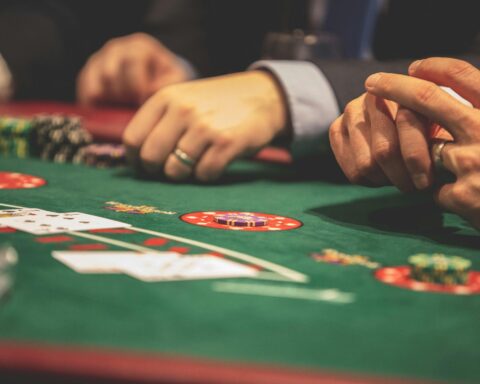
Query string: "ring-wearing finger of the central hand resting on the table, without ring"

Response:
xmin=165 ymin=126 xmax=212 ymax=180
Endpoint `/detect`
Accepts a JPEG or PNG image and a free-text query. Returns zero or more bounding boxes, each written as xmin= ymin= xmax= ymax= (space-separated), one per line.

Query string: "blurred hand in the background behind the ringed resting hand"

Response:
xmin=77 ymin=33 xmax=188 ymax=105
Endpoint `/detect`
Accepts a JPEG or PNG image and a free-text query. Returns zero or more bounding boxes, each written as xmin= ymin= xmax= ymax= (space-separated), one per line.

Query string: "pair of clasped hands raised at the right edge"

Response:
xmin=330 ymin=58 xmax=480 ymax=229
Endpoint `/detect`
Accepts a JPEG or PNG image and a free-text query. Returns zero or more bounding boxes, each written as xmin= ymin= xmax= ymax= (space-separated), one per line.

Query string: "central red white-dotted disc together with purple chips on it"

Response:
xmin=180 ymin=211 xmax=303 ymax=232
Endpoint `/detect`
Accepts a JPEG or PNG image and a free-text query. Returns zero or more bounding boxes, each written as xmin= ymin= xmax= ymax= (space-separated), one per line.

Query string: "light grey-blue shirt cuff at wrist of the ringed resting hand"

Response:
xmin=249 ymin=60 xmax=340 ymax=157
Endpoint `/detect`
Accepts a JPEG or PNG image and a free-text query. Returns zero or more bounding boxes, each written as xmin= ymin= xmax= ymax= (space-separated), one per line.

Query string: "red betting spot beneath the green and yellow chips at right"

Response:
xmin=375 ymin=265 xmax=480 ymax=295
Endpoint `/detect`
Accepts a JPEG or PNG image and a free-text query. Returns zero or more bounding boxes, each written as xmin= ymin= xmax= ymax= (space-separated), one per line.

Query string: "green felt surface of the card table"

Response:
xmin=0 ymin=158 xmax=480 ymax=382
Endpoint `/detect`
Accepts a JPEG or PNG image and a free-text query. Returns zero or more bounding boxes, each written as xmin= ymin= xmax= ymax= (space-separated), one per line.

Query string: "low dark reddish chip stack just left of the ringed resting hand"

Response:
xmin=73 ymin=144 xmax=126 ymax=168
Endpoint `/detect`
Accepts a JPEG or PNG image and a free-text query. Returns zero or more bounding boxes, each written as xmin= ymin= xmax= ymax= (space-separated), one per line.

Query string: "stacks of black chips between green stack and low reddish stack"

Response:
xmin=32 ymin=115 xmax=92 ymax=163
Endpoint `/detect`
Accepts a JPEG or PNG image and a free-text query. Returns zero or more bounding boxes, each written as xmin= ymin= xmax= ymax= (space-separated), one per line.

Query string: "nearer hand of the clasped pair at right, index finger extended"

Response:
xmin=365 ymin=58 xmax=480 ymax=229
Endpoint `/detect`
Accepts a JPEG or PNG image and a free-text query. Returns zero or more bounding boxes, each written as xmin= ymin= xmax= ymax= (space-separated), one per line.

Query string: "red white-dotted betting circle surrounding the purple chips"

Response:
xmin=180 ymin=211 xmax=303 ymax=232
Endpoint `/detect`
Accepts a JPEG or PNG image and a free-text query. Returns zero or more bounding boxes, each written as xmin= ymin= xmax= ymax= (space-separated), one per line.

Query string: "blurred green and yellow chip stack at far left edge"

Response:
xmin=0 ymin=117 xmax=34 ymax=158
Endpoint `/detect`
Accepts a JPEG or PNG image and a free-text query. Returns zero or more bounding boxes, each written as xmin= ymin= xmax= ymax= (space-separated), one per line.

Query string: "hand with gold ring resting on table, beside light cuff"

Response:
xmin=123 ymin=71 xmax=287 ymax=181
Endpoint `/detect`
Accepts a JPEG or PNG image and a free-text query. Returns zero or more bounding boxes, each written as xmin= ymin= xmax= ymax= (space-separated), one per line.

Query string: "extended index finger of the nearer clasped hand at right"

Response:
xmin=365 ymin=73 xmax=478 ymax=142
